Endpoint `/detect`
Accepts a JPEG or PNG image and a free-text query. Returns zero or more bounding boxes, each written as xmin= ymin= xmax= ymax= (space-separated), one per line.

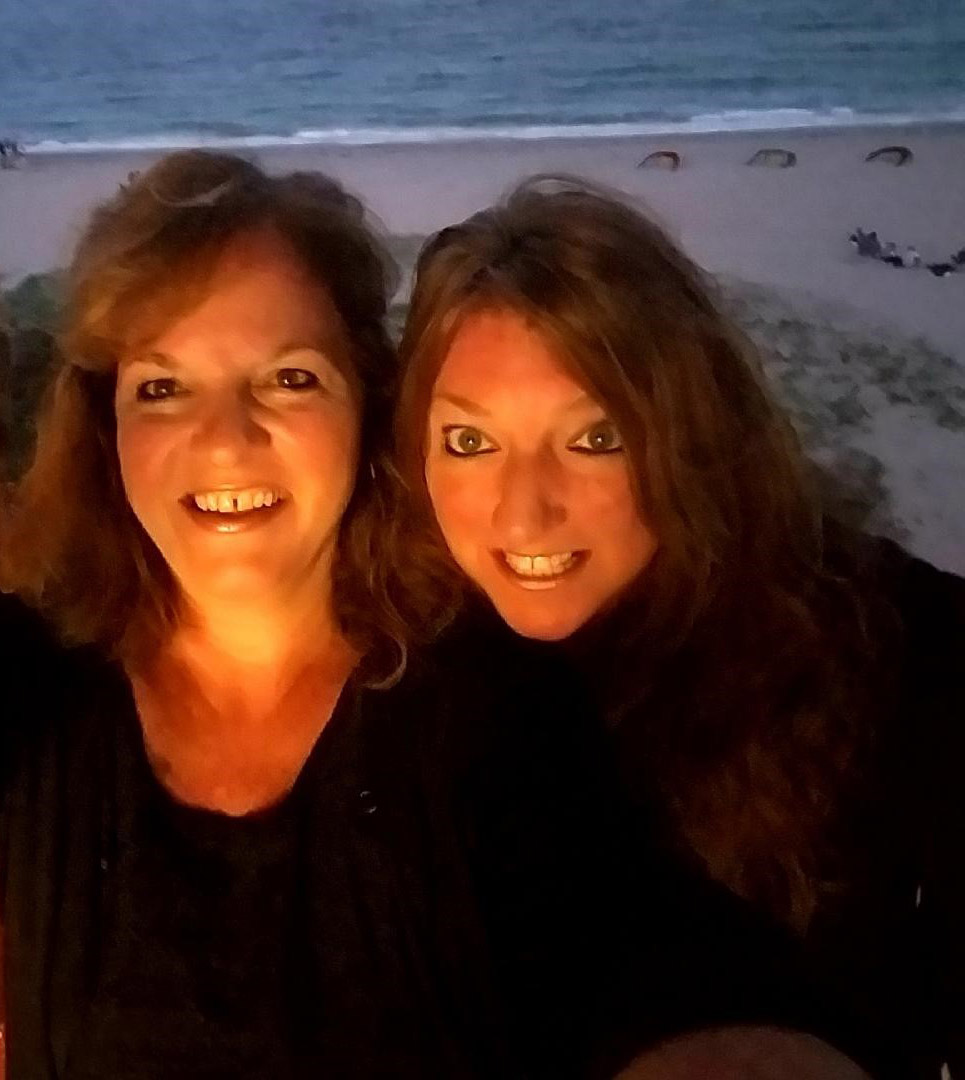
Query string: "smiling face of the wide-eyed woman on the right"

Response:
xmin=425 ymin=310 xmax=656 ymax=640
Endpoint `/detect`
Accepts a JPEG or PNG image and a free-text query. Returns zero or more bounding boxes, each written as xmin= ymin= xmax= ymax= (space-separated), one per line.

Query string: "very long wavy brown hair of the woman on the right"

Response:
xmin=395 ymin=177 xmax=898 ymax=931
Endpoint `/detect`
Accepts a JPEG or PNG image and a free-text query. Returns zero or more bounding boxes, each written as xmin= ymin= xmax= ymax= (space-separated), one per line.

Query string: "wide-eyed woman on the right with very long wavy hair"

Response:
xmin=396 ymin=178 xmax=965 ymax=1080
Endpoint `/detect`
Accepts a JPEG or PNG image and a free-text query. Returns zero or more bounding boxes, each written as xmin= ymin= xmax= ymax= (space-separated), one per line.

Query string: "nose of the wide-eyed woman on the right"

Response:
xmin=492 ymin=454 xmax=567 ymax=549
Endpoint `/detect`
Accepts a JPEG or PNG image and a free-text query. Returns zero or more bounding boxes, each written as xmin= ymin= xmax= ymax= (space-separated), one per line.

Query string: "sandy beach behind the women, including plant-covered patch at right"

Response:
xmin=0 ymin=124 xmax=965 ymax=572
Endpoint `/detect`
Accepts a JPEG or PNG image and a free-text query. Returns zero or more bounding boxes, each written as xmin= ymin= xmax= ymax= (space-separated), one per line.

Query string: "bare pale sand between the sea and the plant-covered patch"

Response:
xmin=0 ymin=125 xmax=965 ymax=347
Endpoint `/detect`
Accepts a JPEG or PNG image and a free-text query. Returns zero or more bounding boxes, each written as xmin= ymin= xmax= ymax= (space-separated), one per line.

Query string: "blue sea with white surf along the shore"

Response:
xmin=0 ymin=0 xmax=965 ymax=151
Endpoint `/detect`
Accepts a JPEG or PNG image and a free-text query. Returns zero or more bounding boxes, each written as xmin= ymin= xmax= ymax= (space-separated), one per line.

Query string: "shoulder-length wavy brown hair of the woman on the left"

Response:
xmin=0 ymin=150 xmax=405 ymax=677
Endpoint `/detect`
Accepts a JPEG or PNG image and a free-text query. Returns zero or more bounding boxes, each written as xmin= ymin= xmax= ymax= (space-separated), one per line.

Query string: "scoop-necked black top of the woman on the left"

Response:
xmin=0 ymin=597 xmax=889 ymax=1080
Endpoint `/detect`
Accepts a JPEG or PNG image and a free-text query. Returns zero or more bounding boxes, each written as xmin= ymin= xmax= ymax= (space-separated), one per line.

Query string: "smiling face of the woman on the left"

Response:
xmin=114 ymin=230 xmax=359 ymax=617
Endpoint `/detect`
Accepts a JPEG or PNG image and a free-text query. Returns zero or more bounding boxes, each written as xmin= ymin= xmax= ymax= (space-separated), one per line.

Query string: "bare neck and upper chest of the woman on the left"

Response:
xmin=130 ymin=592 xmax=358 ymax=813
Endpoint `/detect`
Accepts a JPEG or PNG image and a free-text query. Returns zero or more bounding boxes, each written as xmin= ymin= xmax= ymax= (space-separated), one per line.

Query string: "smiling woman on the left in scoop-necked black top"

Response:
xmin=0 ymin=151 xmax=876 ymax=1080
